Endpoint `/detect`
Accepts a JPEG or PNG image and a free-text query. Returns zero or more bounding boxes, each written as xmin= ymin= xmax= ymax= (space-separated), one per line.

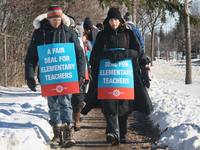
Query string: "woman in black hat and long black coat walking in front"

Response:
xmin=82 ymin=8 xmax=152 ymax=146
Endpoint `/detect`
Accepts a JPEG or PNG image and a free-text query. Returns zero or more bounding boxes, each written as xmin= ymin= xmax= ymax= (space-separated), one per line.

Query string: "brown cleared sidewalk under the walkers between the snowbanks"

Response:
xmin=49 ymin=108 xmax=162 ymax=150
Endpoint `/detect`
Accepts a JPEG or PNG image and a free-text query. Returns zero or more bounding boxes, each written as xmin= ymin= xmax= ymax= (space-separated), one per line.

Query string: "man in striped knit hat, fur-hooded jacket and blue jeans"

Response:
xmin=25 ymin=5 xmax=85 ymax=147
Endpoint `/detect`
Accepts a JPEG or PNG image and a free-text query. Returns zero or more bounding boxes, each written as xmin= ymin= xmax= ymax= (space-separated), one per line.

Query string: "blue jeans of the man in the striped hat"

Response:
xmin=47 ymin=94 xmax=74 ymax=126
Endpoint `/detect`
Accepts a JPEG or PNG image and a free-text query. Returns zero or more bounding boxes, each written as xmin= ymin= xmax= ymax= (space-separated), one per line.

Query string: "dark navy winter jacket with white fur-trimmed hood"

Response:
xmin=24 ymin=14 xmax=85 ymax=79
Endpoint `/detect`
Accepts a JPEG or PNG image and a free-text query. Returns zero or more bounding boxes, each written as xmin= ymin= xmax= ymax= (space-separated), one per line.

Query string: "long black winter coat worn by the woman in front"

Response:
xmin=81 ymin=19 xmax=153 ymax=115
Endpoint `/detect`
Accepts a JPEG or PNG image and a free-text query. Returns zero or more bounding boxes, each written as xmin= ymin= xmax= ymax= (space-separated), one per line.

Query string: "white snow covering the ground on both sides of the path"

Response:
xmin=0 ymin=61 xmax=200 ymax=150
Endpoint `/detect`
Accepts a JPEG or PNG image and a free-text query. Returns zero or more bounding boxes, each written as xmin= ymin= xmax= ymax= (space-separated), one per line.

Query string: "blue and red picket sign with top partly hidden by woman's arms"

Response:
xmin=98 ymin=48 xmax=135 ymax=100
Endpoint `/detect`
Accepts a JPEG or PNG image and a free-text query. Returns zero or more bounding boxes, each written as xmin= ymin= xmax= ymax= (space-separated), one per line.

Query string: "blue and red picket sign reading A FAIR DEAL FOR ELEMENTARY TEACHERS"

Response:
xmin=37 ymin=43 xmax=80 ymax=97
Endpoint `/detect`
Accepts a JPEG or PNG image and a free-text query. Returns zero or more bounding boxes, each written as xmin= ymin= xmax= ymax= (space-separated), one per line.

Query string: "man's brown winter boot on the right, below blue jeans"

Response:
xmin=62 ymin=123 xmax=76 ymax=148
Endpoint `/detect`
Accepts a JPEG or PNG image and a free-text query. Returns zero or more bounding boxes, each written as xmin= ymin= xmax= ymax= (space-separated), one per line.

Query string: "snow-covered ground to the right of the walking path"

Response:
xmin=148 ymin=62 xmax=200 ymax=150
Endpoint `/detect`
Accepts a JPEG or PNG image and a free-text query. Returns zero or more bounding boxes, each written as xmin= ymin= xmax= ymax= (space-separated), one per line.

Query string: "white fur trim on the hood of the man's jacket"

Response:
xmin=33 ymin=13 xmax=70 ymax=29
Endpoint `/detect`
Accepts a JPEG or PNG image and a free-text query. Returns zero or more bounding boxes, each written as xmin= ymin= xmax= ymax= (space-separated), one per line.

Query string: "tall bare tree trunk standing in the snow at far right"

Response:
xmin=184 ymin=0 xmax=192 ymax=84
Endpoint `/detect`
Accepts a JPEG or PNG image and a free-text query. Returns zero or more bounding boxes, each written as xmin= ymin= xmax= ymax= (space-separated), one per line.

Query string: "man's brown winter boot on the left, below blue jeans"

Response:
xmin=49 ymin=124 xmax=62 ymax=147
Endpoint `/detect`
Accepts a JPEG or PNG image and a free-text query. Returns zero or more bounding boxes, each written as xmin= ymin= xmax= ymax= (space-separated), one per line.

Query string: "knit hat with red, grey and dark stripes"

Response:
xmin=47 ymin=5 xmax=62 ymax=19
